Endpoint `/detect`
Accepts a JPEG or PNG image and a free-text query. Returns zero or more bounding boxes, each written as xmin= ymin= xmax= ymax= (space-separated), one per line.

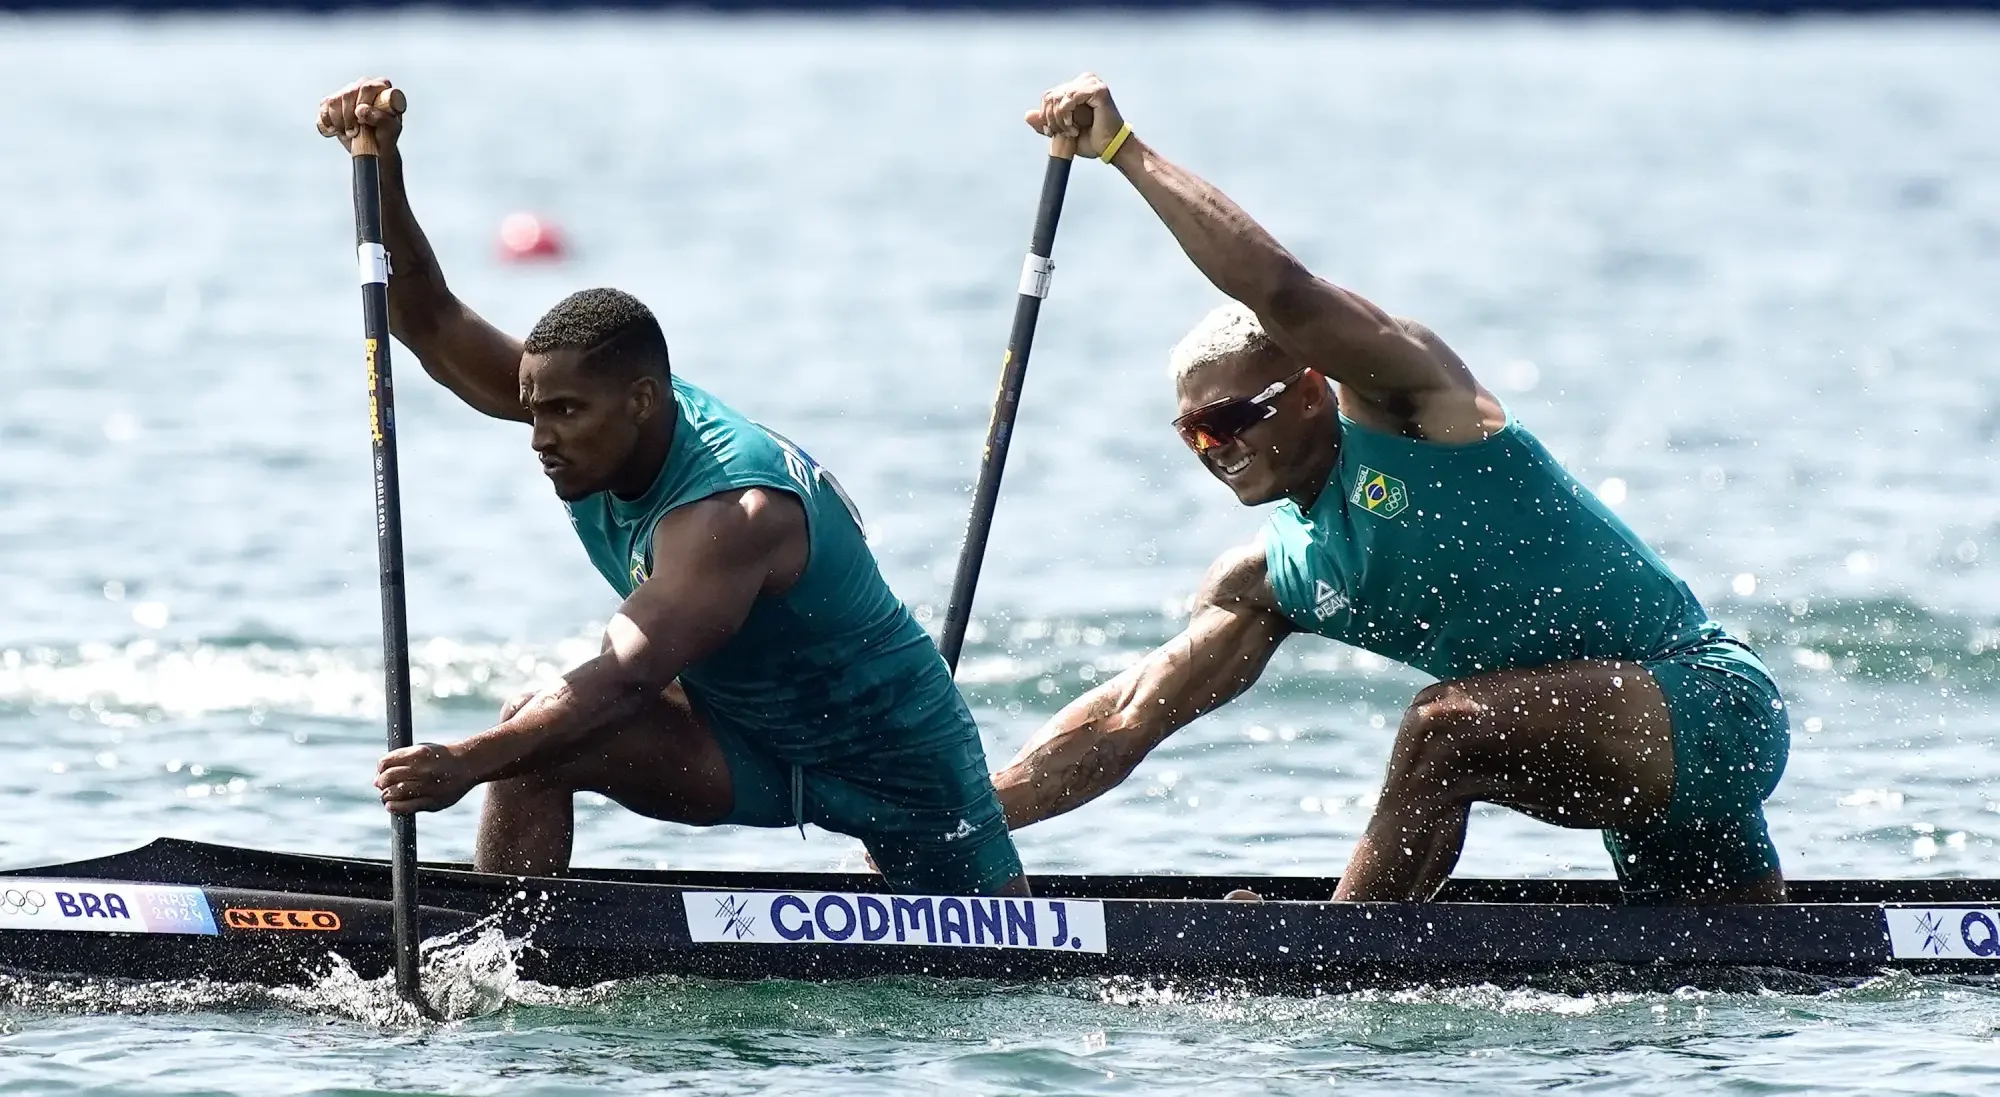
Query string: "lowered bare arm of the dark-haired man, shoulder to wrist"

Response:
xmin=454 ymin=488 xmax=806 ymax=781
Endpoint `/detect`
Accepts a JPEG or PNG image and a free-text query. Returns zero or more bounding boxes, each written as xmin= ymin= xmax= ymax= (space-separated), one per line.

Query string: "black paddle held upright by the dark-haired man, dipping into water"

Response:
xmin=350 ymin=90 xmax=424 ymax=1007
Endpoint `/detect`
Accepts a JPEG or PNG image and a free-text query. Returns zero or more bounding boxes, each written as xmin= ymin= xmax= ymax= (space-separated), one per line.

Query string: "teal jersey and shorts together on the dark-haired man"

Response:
xmin=552 ymin=376 xmax=1020 ymax=891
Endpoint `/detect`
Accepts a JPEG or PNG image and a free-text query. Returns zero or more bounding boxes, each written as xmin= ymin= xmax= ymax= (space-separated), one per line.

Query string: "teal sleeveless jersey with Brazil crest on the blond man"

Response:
xmin=1264 ymin=404 xmax=1724 ymax=679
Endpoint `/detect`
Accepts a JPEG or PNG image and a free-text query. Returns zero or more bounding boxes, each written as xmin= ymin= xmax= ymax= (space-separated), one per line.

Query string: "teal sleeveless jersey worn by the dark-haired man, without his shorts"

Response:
xmin=570 ymin=376 xmax=978 ymax=773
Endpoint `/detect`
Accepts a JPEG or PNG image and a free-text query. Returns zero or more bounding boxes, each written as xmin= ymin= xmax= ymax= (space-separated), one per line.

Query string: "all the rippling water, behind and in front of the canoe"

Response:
xmin=0 ymin=16 xmax=2000 ymax=1095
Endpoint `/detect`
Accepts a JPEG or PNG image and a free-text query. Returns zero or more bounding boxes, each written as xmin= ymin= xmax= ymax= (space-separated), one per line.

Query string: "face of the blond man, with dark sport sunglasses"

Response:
xmin=1176 ymin=350 xmax=1330 ymax=506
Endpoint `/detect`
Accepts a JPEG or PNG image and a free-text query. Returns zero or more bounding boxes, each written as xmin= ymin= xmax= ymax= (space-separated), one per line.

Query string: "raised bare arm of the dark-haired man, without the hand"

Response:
xmin=382 ymin=144 xmax=528 ymax=422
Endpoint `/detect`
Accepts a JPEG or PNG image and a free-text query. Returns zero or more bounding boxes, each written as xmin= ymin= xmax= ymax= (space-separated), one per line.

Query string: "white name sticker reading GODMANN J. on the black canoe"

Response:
xmin=680 ymin=891 xmax=1106 ymax=953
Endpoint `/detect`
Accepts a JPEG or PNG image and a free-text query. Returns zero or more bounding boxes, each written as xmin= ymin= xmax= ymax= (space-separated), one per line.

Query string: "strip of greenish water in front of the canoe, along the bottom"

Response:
xmin=0 ymin=979 xmax=2000 ymax=1093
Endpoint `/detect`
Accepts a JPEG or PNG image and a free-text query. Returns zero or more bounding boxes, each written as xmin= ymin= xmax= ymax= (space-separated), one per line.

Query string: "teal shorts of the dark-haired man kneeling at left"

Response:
xmin=714 ymin=725 xmax=1022 ymax=895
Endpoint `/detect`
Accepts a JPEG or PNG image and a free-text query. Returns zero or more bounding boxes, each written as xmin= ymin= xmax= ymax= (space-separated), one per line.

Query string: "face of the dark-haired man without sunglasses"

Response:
xmin=520 ymin=350 xmax=660 ymax=502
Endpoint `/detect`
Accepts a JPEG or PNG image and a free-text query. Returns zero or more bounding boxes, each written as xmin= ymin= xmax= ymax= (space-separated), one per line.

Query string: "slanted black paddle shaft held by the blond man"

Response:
xmin=938 ymin=136 xmax=1076 ymax=673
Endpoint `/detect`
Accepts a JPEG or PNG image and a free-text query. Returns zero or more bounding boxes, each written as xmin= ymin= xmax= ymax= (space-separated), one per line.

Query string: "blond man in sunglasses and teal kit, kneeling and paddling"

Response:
xmin=994 ymin=74 xmax=1788 ymax=903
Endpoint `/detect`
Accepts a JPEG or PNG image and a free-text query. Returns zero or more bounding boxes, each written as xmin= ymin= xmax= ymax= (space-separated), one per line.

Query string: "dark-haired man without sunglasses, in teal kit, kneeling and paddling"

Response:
xmin=320 ymin=80 xmax=1026 ymax=895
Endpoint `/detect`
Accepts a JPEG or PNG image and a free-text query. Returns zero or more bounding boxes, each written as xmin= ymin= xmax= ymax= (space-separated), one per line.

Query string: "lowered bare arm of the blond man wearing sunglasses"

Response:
xmin=994 ymin=542 xmax=1292 ymax=829
